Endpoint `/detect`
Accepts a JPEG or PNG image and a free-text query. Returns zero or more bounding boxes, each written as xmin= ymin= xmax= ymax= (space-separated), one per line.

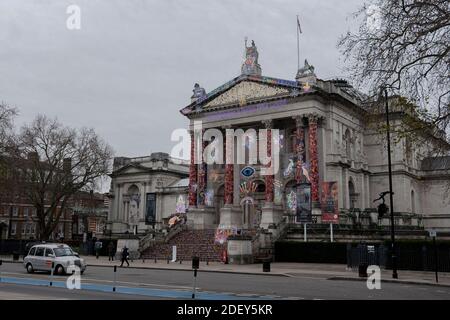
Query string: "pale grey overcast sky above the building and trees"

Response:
xmin=0 ymin=0 xmax=362 ymax=156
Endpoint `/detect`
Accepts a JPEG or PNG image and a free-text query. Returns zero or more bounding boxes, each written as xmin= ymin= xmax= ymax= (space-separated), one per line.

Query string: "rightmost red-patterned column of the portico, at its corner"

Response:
xmin=308 ymin=114 xmax=320 ymax=204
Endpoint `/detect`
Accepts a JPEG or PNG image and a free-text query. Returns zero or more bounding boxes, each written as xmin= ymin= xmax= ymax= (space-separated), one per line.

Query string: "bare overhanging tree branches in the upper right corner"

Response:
xmin=338 ymin=0 xmax=450 ymax=146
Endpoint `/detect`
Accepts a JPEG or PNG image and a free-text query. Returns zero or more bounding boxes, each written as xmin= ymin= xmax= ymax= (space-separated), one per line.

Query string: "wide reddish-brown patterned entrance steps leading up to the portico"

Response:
xmin=141 ymin=229 xmax=224 ymax=261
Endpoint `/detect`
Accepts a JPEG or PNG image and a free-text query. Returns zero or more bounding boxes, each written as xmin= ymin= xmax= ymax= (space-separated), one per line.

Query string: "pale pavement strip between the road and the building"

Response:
xmin=0 ymin=256 xmax=450 ymax=287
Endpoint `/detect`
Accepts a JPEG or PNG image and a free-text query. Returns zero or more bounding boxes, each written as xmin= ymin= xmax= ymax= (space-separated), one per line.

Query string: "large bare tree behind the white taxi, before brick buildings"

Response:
xmin=15 ymin=115 xmax=113 ymax=240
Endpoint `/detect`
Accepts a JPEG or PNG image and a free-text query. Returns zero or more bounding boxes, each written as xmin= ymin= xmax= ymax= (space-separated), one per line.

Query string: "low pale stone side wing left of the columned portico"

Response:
xmin=107 ymin=153 xmax=189 ymax=237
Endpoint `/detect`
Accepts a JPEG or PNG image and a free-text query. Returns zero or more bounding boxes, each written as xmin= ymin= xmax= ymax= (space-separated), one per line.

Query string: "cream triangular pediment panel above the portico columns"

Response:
xmin=203 ymin=81 xmax=289 ymax=109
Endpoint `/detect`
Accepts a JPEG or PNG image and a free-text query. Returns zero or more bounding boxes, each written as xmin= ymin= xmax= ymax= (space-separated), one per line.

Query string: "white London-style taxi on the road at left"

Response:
xmin=23 ymin=243 xmax=87 ymax=275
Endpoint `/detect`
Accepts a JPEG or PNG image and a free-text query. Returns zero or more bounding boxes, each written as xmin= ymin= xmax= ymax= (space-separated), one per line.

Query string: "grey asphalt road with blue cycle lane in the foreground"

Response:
xmin=0 ymin=263 xmax=450 ymax=300
